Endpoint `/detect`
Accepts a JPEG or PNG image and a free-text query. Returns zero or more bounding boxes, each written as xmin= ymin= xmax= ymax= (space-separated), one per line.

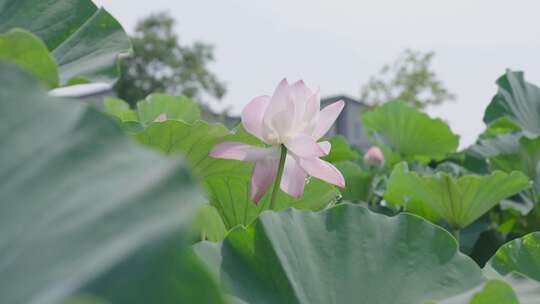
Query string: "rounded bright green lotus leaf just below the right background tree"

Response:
xmin=362 ymin=101 xmax=459 ymax=160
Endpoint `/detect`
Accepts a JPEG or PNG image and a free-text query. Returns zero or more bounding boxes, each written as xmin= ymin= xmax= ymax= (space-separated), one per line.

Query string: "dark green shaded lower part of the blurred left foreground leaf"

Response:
xmin=84 ymin=247 xmax=226 ymax=304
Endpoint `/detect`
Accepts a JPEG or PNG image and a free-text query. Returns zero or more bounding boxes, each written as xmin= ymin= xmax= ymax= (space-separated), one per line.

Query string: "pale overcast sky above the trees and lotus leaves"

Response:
xmin=94 ymin=0 xmax=540 ymax=146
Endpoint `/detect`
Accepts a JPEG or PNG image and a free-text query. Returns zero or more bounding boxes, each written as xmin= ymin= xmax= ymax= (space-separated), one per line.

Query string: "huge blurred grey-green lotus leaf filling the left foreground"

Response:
xmin=0 ymin=64 xmax=224 ymax=304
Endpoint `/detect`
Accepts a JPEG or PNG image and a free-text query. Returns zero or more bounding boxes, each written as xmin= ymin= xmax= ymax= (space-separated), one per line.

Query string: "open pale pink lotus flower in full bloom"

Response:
xmin=210 ymin=79 xmax=345 ymax=202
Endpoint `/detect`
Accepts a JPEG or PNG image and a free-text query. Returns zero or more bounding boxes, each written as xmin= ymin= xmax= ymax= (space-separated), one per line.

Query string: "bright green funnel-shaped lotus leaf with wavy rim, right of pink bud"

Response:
xmin=384 ymin=163 xmax=529 ymax=228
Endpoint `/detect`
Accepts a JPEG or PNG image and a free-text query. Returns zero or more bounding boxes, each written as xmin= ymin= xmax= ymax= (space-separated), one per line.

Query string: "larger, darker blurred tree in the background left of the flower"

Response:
xmin=115 ymin=13 xmax=225 ymax=104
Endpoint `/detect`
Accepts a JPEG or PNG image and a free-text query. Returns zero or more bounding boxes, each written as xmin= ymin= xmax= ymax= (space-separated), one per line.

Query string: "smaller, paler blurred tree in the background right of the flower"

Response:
xmin=360 ymin=49 xmax=455 ymax=109
